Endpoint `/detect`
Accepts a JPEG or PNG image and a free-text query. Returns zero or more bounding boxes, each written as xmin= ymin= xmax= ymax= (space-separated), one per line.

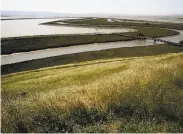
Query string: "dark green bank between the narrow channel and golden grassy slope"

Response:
xmin=1 ymin=45 xmax=183 ymax=74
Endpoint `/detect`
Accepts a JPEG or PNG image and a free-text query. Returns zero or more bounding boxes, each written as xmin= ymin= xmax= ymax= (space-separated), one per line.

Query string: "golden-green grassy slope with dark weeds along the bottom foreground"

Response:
xmin=1 ymin=53 xmax=183 ymax=132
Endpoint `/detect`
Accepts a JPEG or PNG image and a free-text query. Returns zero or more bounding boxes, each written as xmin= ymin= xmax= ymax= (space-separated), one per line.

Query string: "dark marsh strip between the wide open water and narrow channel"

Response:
xmin=1 ymin=32 xmax=138 ymax=54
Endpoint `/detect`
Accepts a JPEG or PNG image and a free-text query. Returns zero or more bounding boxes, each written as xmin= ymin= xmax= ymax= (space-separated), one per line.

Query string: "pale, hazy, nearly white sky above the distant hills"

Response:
xmin=1 ymin=0 xmax=183 ymax=15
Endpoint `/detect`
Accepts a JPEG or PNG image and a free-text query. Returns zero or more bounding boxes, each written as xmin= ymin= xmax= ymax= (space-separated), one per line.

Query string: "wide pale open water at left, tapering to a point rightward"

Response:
xmin=1 ymin=19 xmax=135 ymax=37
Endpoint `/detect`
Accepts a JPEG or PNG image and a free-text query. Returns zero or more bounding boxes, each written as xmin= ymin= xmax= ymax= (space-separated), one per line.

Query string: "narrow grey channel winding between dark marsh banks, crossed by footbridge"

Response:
xmin=1 ymin=20 xmax=183 ymax=65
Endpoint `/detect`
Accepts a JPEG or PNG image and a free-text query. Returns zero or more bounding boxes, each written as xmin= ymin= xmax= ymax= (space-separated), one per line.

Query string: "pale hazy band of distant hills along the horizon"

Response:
xmin=1 ymin=10 xmax=183 ymax=20
